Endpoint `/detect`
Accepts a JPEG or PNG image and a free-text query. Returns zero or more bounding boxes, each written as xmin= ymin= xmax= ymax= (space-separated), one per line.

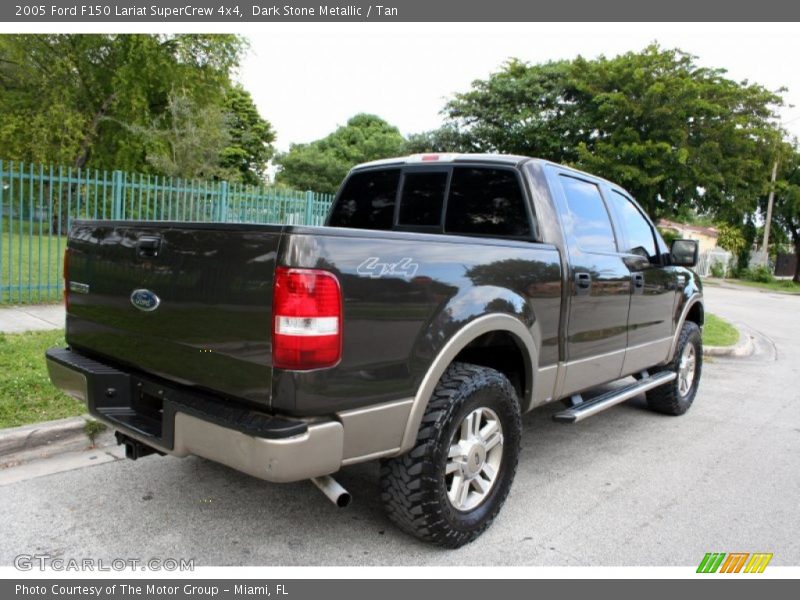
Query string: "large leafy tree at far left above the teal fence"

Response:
xmin=0 ymin=34 xmax=244 ymax=169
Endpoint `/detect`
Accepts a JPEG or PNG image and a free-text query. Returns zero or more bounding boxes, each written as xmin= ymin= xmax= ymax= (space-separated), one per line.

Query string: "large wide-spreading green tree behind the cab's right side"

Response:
xmin=444 ymin=45 xmax=781 ymax=222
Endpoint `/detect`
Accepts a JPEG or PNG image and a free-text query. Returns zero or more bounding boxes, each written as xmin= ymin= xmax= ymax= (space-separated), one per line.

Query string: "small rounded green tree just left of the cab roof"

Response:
xmin=275 ymin=114 xmax=405 ymax=193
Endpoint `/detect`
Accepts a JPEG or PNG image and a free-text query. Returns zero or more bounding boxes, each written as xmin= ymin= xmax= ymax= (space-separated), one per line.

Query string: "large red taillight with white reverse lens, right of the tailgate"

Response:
xmin=272 ymin=267 xmax=342 ymax=371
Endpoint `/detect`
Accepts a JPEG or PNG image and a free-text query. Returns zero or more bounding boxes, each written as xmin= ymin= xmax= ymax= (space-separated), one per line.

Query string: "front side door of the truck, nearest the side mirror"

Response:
xmin=606 ymin=188 xmax=678 ymax=375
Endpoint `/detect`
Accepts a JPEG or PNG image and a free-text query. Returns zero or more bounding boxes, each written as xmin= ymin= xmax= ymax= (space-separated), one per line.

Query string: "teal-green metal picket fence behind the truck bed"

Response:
xmin=0 ymin=160 xmax=333 ymax=304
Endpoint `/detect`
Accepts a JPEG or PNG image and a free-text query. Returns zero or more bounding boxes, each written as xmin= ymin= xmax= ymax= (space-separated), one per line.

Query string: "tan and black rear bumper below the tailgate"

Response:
xmin=47 ymin=348 xmax=344 ymax=482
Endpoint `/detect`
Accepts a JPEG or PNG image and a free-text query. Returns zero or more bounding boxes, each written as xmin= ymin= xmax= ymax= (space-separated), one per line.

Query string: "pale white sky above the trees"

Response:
xmin=237 ymin=23 xmax=800 ymax=150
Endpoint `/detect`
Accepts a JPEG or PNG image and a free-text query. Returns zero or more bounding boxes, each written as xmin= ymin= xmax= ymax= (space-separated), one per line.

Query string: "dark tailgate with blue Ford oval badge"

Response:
xmin=66 ymin=221 xmax=282 ymax=406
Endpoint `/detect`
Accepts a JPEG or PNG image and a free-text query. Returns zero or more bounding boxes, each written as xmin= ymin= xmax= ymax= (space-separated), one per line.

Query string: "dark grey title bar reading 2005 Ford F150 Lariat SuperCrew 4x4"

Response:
xmin=0 ymin=0 xmax=800 ymax=23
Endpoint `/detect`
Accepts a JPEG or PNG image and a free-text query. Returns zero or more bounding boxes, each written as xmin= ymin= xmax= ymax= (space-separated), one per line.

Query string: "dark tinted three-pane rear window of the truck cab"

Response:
xmin=328 ymin=164 xmax=533 ymax=239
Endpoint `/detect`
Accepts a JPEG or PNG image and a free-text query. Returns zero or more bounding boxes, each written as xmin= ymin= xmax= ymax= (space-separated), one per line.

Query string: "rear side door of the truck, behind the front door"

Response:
xmin=548 ymin=167 xmax=631 ymax=395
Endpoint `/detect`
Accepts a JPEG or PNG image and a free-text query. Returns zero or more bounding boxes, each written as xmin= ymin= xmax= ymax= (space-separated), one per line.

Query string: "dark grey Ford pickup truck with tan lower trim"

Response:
xmin=47 ymin=155 xmax=703 ymax=547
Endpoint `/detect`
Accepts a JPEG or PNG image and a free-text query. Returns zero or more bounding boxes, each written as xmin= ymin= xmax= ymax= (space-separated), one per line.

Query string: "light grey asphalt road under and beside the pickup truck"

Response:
xmin=0 ymin=287 xmax=800 ymax=565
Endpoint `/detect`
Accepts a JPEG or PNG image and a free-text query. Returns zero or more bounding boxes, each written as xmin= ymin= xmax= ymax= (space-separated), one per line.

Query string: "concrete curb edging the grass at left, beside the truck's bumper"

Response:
xmin=0 ymin=415 xmax=89 ymax=463
